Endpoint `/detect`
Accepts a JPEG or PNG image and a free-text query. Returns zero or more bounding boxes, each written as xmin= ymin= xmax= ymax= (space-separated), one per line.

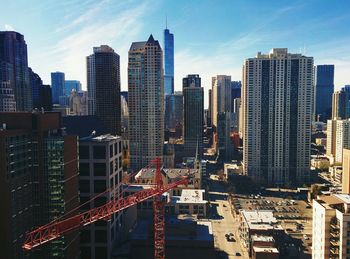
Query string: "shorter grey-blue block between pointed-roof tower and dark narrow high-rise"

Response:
xmin=164 ymin=92 xmax=183 ymax=131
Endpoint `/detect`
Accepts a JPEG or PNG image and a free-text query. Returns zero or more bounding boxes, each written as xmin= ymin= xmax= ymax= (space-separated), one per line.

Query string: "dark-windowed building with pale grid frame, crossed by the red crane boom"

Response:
xmin=79 ymin=134 xmax=123 ymax=259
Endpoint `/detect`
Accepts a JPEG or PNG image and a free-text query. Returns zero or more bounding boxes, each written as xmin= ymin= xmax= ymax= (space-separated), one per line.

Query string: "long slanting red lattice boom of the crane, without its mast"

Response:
xmin=22 ymin=177 xmax=188 ymax=250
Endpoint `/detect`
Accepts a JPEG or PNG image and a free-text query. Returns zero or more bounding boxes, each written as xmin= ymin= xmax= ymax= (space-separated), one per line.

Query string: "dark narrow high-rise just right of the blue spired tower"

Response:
xmin=182 ymin=75 xmax=204 ymax=158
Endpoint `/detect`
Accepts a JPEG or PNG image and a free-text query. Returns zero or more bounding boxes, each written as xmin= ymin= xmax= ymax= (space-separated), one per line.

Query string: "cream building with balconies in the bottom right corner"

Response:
xmin=312 ymin=194 xmax=350 ymax=259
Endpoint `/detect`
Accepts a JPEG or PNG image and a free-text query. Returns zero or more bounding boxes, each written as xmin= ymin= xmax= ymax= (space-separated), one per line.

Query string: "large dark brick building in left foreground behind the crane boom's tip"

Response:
xmin=0 ymin=112 xmax=80 ymax=259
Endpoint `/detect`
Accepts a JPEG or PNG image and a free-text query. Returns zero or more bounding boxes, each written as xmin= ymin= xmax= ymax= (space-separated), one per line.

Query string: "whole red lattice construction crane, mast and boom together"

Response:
xmin=22 ymin=158 xmax=188 ymax=259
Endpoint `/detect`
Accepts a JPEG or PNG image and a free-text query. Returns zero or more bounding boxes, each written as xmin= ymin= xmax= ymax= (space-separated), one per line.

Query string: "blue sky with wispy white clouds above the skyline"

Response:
xmin=0 ymin=0 xmax=350 ymax=104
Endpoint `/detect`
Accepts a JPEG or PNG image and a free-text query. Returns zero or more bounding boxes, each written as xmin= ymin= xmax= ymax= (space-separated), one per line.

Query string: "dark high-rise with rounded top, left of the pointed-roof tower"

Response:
xmin=87 ymin=45 xmax=120 ymax=135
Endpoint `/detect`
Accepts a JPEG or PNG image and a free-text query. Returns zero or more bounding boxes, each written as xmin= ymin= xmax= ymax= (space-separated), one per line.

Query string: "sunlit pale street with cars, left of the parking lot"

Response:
xmin=209 ymin=180 xmax=249 ymax=259
